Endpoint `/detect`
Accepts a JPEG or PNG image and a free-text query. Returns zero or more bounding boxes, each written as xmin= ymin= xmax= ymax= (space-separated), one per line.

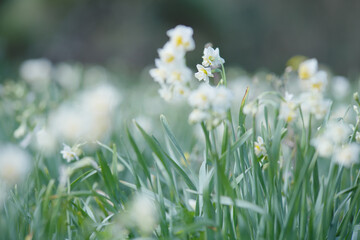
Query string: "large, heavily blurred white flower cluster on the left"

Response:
xmin=49 ymin=84 xmax=121 ymax=144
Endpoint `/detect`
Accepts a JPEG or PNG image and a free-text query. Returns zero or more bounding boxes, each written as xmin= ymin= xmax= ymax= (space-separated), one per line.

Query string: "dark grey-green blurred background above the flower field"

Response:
xmin=0 ymin=0 xmax=360 ymax=78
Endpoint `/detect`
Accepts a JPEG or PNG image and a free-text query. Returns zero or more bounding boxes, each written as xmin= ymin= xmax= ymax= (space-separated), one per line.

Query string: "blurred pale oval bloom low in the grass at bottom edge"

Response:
xmin=129 ymin=193 xmax=158 ymax=234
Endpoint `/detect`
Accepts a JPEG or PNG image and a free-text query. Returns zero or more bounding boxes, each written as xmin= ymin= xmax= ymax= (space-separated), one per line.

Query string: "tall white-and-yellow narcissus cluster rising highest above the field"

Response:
xmin=150 ymin=25 xmax=195 ymax=101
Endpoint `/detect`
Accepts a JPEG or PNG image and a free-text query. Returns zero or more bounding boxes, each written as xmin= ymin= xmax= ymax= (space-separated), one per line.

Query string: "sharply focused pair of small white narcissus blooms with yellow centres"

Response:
xmin=195 ymin=46 xmax=225 ymax=83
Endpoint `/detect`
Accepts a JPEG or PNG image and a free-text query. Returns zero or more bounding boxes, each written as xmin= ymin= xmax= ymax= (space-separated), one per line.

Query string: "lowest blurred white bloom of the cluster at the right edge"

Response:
xmin=333 ymin=143 xmax=360 ymax=167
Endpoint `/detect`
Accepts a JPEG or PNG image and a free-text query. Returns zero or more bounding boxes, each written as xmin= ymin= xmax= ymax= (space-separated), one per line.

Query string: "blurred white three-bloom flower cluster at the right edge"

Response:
xmin=312 ymin=121 xmax=360 ymax=167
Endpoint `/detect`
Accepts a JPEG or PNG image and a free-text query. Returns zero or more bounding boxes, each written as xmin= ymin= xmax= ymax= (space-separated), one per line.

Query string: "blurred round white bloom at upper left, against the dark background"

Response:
xmin=20 ymin=58 xmax=51 ymax=88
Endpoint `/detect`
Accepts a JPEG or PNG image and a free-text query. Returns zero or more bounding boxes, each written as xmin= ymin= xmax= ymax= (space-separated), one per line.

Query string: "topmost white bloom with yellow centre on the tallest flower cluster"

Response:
xmin=167 ymin=25 xmax=195 ymax=51
